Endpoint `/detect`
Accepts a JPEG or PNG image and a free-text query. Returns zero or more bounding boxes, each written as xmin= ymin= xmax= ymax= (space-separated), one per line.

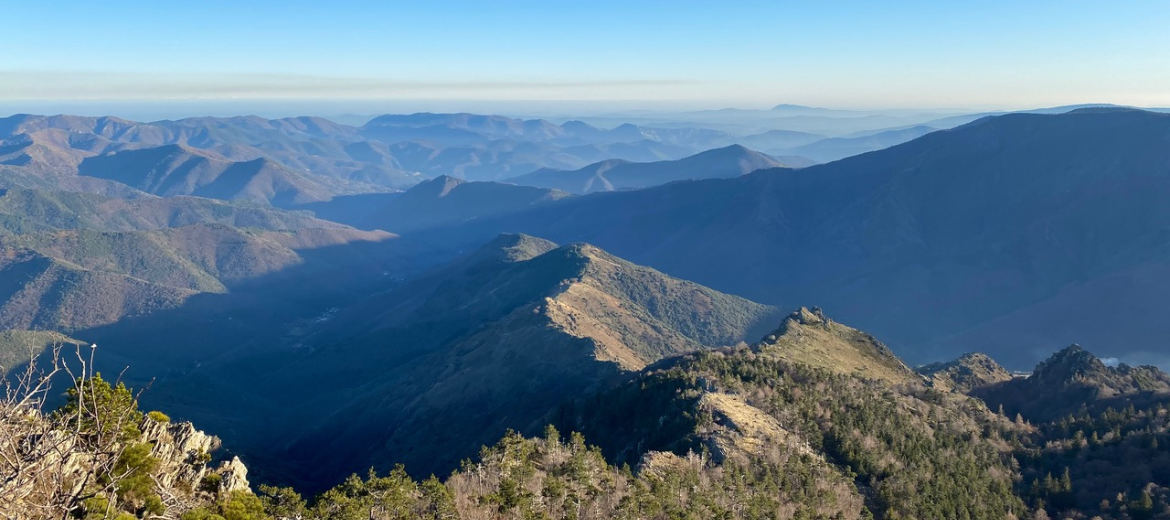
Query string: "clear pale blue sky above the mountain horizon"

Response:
xmin=0 ymin=0 xmax=1170 ymax=108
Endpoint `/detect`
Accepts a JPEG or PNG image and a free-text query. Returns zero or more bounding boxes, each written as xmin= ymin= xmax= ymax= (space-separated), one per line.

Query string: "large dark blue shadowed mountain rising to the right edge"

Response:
xmin=400 ymin=109 xmax=1170 ymax=365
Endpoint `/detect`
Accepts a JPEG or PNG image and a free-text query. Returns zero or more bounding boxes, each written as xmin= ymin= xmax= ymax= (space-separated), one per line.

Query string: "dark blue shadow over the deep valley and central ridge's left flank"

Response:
xmin=54 ymin=233 xmax=655 ymax=492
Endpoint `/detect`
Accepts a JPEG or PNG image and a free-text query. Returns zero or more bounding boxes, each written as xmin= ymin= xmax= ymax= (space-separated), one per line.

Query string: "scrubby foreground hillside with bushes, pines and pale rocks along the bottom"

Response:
xmin=11 ymin=334 xmax=1170 ymax=520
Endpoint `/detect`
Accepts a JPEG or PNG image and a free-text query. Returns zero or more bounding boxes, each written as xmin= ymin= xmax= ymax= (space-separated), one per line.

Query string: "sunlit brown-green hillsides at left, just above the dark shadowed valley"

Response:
xmin=0 ymin=183 xmax=427 ymax=355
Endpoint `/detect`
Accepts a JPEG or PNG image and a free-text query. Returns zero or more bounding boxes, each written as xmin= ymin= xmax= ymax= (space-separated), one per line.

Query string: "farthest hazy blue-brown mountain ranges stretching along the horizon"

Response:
xmin=0 ymin=107 xmax=1006 ymax=207
